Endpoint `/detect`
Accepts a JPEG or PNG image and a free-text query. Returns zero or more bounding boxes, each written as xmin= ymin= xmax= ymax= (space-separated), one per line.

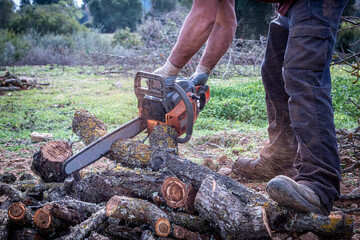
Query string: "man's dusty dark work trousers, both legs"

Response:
xmin=260 ymin=0 xmax=348 ymax=211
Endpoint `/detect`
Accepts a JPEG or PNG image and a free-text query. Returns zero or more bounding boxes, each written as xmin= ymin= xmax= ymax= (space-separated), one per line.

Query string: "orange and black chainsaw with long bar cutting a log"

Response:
xmin=63 ymin=72 xmax=210 ymax=176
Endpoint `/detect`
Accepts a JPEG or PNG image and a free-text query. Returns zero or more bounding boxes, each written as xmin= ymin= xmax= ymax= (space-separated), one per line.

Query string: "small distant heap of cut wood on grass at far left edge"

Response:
xmin=0 ymin=71 xmax=49 ymax=92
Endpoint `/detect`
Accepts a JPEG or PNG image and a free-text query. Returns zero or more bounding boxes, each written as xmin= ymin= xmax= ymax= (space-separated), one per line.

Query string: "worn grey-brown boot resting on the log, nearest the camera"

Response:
xmin=266 ymin=175 xmax=330 ymax=216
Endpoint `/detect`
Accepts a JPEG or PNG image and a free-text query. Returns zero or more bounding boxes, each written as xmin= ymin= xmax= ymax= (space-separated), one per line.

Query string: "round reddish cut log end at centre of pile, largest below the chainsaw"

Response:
xmin=161 ymin=177 xmax=188 ymax=208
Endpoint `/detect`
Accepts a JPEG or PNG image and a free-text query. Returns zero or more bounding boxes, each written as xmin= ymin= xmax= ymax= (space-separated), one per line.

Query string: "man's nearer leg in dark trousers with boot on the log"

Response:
xmin=267 ymin=0 xmax=347 ymax=214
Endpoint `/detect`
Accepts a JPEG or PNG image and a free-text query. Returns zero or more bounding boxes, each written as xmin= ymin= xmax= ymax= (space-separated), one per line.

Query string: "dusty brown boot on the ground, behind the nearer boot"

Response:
xmin=232 ymin=158 xmax=296 ymax=181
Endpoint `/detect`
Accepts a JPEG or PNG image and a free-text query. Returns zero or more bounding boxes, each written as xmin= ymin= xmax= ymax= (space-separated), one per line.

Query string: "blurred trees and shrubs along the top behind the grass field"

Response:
xmin=0 ymin=0 xmax=360 ymax=66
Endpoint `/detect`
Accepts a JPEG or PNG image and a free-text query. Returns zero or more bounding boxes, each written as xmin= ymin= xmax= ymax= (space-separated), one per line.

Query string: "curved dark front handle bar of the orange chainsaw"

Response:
xmin=172 ymin=83 xmax=194 ymax=143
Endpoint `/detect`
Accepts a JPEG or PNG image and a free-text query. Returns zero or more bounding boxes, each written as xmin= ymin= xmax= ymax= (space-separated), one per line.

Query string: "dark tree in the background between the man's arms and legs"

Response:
xmin=235 ymin=0 xmax=274 ymax=39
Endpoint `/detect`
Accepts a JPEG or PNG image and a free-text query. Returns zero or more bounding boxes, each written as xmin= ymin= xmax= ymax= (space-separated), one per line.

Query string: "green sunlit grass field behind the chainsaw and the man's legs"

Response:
xmin=0 ymin=66 xmax=360 ymax=153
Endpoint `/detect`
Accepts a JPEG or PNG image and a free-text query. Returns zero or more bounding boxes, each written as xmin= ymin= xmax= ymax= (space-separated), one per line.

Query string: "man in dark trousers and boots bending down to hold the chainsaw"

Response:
xmin=156 ymin=0 xmax=348 ymax=215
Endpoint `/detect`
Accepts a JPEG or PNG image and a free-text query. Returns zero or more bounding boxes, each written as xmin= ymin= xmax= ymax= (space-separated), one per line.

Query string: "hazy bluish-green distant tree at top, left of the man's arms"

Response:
xmin=89 ymin=0 xmax=142 ymax=33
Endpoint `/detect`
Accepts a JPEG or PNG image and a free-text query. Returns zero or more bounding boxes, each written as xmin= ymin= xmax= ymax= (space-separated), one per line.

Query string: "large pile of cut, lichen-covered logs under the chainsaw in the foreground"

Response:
xmin=0 ymin=111 xmax=354 ymax=240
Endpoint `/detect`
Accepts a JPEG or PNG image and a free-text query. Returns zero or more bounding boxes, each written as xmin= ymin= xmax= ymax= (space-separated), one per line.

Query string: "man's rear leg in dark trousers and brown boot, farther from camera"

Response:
xmin=234 ymin=15 xmax=297 ymax=180
